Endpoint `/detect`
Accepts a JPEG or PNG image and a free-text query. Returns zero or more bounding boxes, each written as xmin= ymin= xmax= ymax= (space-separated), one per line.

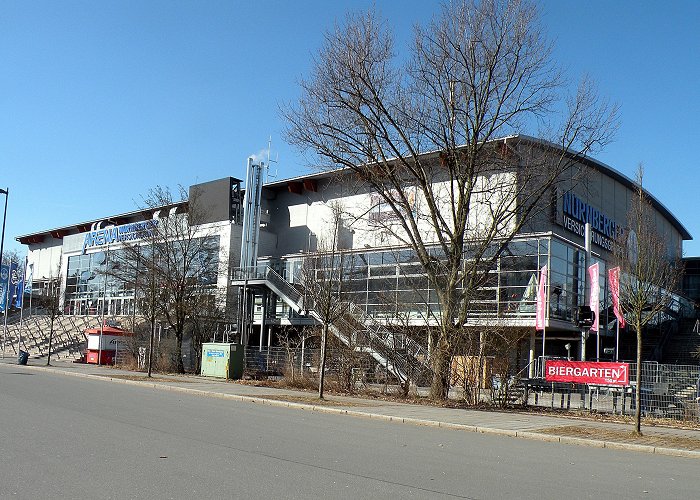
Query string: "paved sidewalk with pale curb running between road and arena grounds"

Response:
xmin=5 ymin=356 xmax=700 ymax=459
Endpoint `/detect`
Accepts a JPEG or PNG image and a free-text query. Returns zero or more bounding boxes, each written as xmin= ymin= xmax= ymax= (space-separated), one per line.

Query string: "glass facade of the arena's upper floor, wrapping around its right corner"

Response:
xmin=261 ymin=235 xmax=609 ymax=328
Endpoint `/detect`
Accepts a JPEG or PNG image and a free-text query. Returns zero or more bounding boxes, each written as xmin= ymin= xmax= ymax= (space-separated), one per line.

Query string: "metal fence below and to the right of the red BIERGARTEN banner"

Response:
xmin=522 ymin=362 xmax=700 ymax=422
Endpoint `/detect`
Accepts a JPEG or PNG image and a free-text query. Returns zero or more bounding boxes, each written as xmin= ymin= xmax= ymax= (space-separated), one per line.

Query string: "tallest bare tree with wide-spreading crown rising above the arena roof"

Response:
xmin=284 ymin=0 xmax=617 ymax=398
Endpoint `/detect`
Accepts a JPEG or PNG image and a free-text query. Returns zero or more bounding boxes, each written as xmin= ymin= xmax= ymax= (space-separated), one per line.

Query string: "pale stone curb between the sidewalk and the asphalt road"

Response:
xmin=15 ymin=365 xmax=700 ymax=459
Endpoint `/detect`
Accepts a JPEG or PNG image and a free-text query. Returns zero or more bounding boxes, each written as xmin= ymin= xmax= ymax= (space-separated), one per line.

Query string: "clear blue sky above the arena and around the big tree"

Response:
xmin=0 ymin=0 xmax=700 ymax=255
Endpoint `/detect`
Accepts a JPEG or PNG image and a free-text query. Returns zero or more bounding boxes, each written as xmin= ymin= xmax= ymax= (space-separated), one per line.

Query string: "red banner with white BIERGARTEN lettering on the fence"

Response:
xmin=545 ymin=360 xmax=630 ymax=386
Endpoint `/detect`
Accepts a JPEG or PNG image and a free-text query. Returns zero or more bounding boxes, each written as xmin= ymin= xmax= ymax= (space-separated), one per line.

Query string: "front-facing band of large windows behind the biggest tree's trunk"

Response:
xmin=288 ymin=237 xmax=560 ymax=321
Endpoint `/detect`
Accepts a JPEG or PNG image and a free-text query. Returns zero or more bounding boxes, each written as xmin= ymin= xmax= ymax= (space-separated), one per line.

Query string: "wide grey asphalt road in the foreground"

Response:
xmin=0 ymin=365 xmax=700 ymax=499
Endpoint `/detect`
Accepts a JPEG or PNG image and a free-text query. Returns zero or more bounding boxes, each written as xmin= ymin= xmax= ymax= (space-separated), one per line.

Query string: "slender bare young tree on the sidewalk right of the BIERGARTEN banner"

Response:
xmin=616 ymin=165 xmax=682 ymax=435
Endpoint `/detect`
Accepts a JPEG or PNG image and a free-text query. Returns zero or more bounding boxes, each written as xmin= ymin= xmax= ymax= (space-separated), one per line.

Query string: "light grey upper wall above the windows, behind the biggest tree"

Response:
xmin=260 ymin=169 xmax=515 ymax=256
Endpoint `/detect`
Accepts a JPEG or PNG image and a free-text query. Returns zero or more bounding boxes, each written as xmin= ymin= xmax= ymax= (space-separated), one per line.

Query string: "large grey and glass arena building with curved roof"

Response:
xmin=17 ymin=136 xmax=692 ymax=376
